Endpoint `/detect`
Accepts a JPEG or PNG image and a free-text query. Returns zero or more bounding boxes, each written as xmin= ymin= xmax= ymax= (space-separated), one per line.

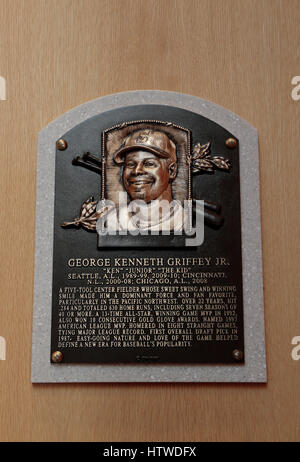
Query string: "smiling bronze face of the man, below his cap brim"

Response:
xmin=122 ymin=150 xmax=176 ymax=203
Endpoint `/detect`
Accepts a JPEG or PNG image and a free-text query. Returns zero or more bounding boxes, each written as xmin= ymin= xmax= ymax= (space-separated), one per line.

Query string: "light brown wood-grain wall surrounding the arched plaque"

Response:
xmin=0 ymin=0 xmax=300 ymax=442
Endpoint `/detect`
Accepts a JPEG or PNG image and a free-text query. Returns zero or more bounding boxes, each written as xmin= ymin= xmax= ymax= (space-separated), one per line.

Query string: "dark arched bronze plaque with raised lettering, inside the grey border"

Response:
xmin=51 ymin=105 xmax=244 ymax=363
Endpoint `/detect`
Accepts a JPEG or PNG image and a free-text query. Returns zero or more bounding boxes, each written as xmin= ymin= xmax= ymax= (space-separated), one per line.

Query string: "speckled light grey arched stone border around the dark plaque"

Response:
xmin=31 ymin=90 xmax=267 ymax=383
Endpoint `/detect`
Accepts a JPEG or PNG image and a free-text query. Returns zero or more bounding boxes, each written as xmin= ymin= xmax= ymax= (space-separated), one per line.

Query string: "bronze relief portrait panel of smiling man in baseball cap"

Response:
xmin=100 ymin=121 xmax=190 ymax=236
